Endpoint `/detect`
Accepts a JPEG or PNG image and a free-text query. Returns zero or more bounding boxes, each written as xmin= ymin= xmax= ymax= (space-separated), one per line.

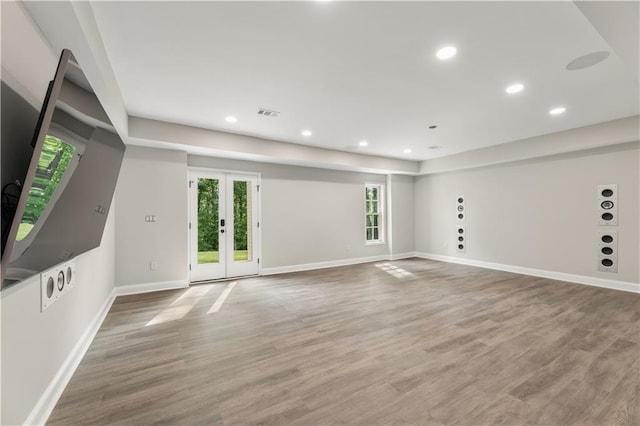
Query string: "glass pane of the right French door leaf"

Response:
xmin=233 ymin=180 xmax=253 ymax=261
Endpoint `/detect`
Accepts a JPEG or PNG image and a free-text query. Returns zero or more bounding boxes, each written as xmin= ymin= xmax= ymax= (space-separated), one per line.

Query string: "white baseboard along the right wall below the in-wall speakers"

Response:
xmin=415 ymin=253 xmax=640 ymax=293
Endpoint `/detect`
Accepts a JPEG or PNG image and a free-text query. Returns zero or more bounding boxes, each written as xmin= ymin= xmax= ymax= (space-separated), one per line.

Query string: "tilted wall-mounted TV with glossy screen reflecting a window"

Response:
xmin=2 ymin=50 xmax=125 ymax=288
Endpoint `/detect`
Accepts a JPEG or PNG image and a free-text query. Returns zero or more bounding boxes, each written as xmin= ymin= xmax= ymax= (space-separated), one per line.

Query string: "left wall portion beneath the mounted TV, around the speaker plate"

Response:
xmin=0 ymin=208 xmax=115 ymax=425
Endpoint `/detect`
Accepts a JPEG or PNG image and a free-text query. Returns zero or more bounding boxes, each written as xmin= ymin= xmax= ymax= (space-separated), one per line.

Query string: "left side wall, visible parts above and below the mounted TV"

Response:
xmin=0 ymin=2 xmax=115 ymax=425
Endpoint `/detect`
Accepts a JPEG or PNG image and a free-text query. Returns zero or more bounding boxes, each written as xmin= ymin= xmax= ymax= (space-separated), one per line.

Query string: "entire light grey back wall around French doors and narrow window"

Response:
xmin=116 ymin=150 xmax=396 ymax=282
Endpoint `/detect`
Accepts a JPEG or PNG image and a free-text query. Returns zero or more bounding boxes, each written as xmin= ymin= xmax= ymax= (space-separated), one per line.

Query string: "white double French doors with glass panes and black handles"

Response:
xmin=189 ymin=171 xmax=259 ymax=282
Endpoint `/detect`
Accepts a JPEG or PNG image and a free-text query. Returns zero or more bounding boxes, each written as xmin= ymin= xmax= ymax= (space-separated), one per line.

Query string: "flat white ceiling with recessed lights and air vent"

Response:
xmin=91 ymin=2 xmax=639 ymax=160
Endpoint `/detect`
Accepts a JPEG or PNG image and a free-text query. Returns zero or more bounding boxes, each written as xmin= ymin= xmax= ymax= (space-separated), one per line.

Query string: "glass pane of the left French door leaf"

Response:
xmin=198 ymin=178 xmax=220 ymax=263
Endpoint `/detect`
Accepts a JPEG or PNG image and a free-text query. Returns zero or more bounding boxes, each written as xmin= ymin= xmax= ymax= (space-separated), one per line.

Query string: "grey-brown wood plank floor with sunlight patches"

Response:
xmin=49 ymin=259 xmax=640 ymax=425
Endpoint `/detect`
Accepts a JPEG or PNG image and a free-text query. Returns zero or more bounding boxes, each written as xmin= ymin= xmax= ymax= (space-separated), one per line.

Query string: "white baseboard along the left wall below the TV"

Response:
xmin=24 ymin=289 xmax=116 ymax=425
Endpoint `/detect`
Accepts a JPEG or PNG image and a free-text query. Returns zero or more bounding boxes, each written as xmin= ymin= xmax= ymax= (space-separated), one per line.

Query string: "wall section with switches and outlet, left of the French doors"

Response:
xmin=115 ymin=146 xmax=188 ymax=287
